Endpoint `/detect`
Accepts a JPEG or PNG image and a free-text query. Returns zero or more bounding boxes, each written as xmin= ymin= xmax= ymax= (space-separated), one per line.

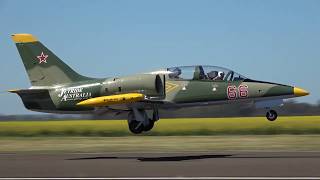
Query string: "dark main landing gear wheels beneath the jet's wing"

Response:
xmin=128 ymin=109 xmax=159 ymax=134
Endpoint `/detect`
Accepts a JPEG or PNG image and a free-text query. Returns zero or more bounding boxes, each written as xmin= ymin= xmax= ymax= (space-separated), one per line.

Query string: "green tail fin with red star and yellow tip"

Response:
xmin=12 ymin=34 xmax=91 ymax=86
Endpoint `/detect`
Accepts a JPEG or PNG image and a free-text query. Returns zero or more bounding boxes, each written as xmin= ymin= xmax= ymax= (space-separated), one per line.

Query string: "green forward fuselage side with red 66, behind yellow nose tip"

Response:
xmin=166 ymin=80 xmax=294 ymax=103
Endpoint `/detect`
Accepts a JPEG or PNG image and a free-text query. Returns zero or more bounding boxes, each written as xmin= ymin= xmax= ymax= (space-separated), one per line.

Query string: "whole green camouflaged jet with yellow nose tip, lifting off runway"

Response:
xmin=10 ymin=34 xmax=309 ymax=134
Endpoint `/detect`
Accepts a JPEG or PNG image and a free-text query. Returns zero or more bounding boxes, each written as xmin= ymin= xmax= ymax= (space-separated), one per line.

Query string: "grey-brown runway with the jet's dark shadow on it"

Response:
xmin=0 ymin=152 xmax=320 ymax=178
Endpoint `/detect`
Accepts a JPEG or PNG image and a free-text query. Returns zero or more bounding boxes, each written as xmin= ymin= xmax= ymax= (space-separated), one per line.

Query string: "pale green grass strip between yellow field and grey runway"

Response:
xmin=0 ymin=135 xmax=320 ymax=153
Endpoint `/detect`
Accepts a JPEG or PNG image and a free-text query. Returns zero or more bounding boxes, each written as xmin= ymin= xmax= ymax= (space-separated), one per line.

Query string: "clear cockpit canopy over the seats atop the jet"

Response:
xmin=167 ymin=65 xmax=247 ymax=81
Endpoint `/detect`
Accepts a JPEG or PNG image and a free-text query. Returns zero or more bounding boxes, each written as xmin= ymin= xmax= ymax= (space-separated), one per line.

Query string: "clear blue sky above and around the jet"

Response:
xmin=0 ymin=0 xmax=320 ymax=114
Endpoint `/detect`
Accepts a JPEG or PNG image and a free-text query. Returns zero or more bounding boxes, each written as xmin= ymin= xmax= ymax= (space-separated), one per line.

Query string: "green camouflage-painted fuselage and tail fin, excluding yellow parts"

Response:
xmin=11 ymin=36 xmax=294 ymax=111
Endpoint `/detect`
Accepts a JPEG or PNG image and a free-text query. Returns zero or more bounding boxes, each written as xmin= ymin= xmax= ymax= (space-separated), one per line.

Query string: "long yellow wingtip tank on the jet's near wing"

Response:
xmin=77 ymin=93 xmax=144 ymax=107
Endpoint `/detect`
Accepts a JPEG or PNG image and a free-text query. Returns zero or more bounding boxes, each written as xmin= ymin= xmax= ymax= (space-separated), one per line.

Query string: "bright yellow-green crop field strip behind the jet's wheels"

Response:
xmin=0 ymin=116 xmax=320 ymax=137
